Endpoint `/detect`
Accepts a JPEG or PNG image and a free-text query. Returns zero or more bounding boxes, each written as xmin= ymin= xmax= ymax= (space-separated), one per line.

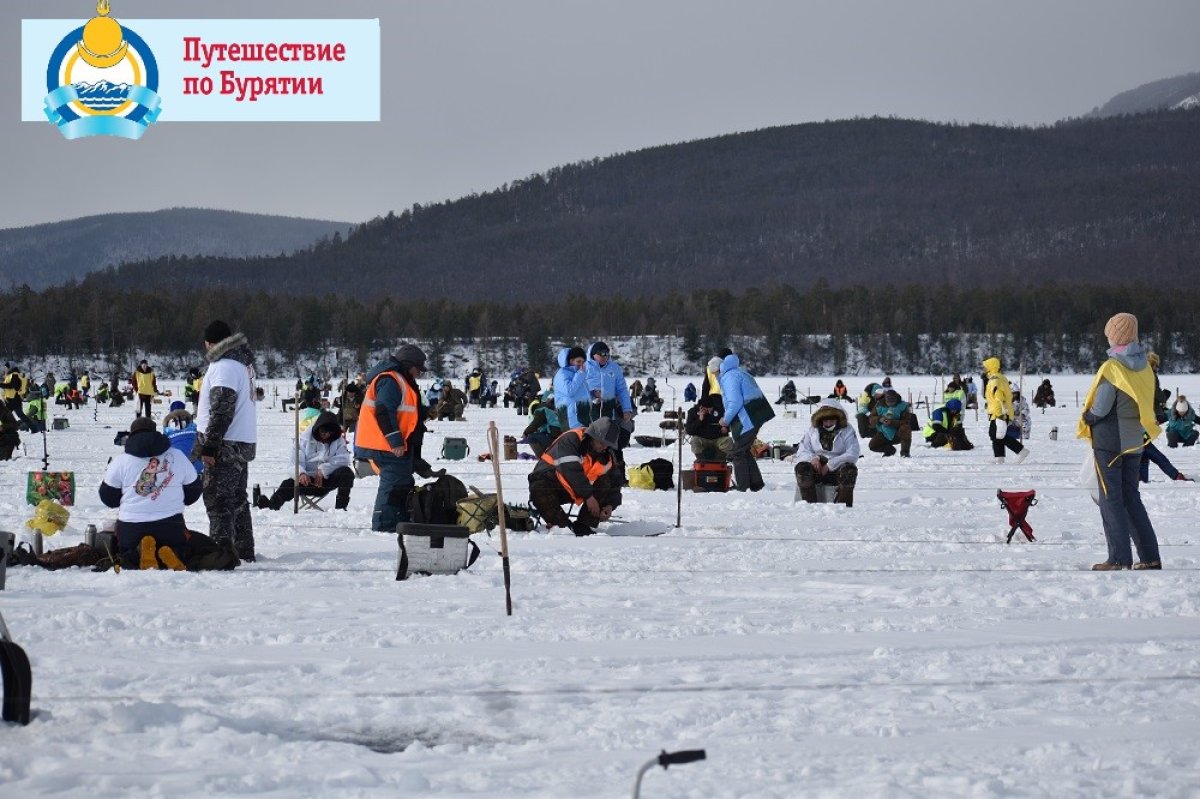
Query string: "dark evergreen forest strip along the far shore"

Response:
xmin=0 ymin=282 xmax=1200 ymax=377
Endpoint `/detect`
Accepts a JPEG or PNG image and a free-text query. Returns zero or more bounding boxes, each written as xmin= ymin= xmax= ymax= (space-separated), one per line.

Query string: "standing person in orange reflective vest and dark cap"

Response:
xmin=354 ymin=344 xmax=431 ymax=533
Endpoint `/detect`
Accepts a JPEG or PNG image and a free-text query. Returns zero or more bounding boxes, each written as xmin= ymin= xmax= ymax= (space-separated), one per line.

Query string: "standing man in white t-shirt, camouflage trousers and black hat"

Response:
xmin=192 ymin=320 xmax=258 ymax=560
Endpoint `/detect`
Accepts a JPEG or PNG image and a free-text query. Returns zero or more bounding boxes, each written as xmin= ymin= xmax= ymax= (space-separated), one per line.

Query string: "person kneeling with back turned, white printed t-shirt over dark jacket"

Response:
xmin=100 ymin=416 xmax=203 ymax=571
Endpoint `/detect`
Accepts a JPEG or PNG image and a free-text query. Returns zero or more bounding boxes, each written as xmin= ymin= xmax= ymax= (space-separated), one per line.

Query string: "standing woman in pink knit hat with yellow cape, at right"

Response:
xmin=1075 ymin=313 xmax=1163 ymax=571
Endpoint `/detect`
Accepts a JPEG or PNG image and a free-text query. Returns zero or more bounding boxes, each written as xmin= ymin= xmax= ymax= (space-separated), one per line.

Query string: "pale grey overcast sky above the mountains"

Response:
xmin=0 ymin=0 xmax=1200 ymax=228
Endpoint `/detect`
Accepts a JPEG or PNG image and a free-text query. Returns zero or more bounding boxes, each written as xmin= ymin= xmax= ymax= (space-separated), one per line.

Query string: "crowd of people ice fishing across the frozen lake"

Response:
xmin=0 ymin=314 xmax=1200 ymax=570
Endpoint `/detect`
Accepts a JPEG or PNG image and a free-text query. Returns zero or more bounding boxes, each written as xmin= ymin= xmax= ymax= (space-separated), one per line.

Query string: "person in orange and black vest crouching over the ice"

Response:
xmin=529 ymin=419 xmax=620 ymax=535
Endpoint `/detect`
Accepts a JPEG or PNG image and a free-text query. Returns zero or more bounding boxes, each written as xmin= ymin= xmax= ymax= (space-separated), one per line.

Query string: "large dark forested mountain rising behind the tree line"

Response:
xmin=79 ymin=109 xmax=1200 ymax=302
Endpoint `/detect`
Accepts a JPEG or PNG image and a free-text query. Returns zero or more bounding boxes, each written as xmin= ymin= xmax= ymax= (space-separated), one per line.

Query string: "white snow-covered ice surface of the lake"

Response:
xmin=0 ymin=376 xmax=1200 ymax=798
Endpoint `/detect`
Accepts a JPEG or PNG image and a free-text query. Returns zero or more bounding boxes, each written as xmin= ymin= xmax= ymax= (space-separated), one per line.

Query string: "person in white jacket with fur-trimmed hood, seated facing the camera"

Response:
xmin=796 ymin=400 xmax=859 ymax=507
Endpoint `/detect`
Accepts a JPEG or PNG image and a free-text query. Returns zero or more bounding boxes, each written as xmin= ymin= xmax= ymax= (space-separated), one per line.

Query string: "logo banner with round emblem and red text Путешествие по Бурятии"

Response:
xmin=20 ymin=7 xmax=380 ymax=139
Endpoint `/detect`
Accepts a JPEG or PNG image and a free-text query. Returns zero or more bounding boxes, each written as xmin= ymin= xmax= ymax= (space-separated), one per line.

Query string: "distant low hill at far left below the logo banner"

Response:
xmin=0 ymin=208 xmax=350 ymax=292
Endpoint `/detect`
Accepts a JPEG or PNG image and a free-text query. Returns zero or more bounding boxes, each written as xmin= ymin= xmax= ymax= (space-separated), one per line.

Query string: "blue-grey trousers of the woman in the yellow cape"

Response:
xmin=1096 ymin=450 xmax=1159 ymax=566
